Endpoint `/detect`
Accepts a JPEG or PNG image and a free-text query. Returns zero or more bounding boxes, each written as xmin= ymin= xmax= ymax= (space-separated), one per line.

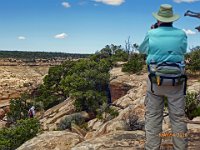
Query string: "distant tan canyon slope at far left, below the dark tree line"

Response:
xmin=0 ymin=58 xmax=65 ymax=108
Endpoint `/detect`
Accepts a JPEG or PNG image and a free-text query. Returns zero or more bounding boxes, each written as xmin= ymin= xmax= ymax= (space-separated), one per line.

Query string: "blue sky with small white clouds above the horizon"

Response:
xmin=0 ymin=0 xmax=200 ymax=53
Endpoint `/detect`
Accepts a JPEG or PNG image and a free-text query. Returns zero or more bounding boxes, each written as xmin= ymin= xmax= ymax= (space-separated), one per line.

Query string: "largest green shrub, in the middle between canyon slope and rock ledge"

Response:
xmin=29 ymin=44 xmax=132 ymax=117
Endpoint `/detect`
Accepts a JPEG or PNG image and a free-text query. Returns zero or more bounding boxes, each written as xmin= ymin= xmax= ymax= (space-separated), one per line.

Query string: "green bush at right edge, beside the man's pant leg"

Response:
xmin=185 ymin=93 xmax=200 ymax=119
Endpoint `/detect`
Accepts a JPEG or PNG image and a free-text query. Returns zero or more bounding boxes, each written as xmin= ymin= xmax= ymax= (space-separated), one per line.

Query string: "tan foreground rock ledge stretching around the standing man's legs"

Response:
xmin=14 ymin=67 xmax=200 ymax=150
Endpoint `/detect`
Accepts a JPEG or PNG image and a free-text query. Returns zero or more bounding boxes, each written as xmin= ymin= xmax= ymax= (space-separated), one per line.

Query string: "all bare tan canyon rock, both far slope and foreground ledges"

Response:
xmin=0 ymin=59 xmax=200 ymax=150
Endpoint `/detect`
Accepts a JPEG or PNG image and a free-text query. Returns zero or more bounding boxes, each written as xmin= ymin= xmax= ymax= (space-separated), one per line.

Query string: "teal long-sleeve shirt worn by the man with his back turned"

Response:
xmin=139 ymin=26 xmax=187 ymax=64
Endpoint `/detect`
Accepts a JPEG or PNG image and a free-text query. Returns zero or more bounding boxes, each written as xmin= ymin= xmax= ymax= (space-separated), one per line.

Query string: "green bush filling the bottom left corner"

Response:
xmin=0 ymin=119 xmax=40 ymax=150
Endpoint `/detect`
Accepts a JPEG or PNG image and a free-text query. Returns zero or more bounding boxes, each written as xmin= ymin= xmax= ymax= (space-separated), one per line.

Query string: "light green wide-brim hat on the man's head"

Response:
xmin=152 ymin=4 xmax=180 ymax=22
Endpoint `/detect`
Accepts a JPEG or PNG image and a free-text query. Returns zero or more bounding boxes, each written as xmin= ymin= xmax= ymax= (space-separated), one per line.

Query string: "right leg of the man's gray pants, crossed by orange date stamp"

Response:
xmin=167 ymin=86 xmax=188 ymax=150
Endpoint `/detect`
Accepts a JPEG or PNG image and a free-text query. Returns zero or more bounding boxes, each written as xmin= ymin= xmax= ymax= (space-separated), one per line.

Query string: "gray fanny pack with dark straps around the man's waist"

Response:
xmin=148 ymin=62 xmax=187 ymax=94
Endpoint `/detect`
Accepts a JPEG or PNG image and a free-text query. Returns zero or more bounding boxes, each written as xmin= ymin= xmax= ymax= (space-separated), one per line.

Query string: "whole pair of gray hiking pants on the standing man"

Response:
xmin=145 ymin=80 xmax=187 ymax=150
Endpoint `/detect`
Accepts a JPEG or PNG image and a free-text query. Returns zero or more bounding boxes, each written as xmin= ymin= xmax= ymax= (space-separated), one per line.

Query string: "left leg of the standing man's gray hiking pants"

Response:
xmin=145 ymin=91 xmax=164 ymax=150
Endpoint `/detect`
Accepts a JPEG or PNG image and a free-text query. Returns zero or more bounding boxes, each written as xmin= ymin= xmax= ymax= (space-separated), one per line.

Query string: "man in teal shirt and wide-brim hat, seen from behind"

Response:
xmin=139 ymin=4 xmax=187 ymax=150
